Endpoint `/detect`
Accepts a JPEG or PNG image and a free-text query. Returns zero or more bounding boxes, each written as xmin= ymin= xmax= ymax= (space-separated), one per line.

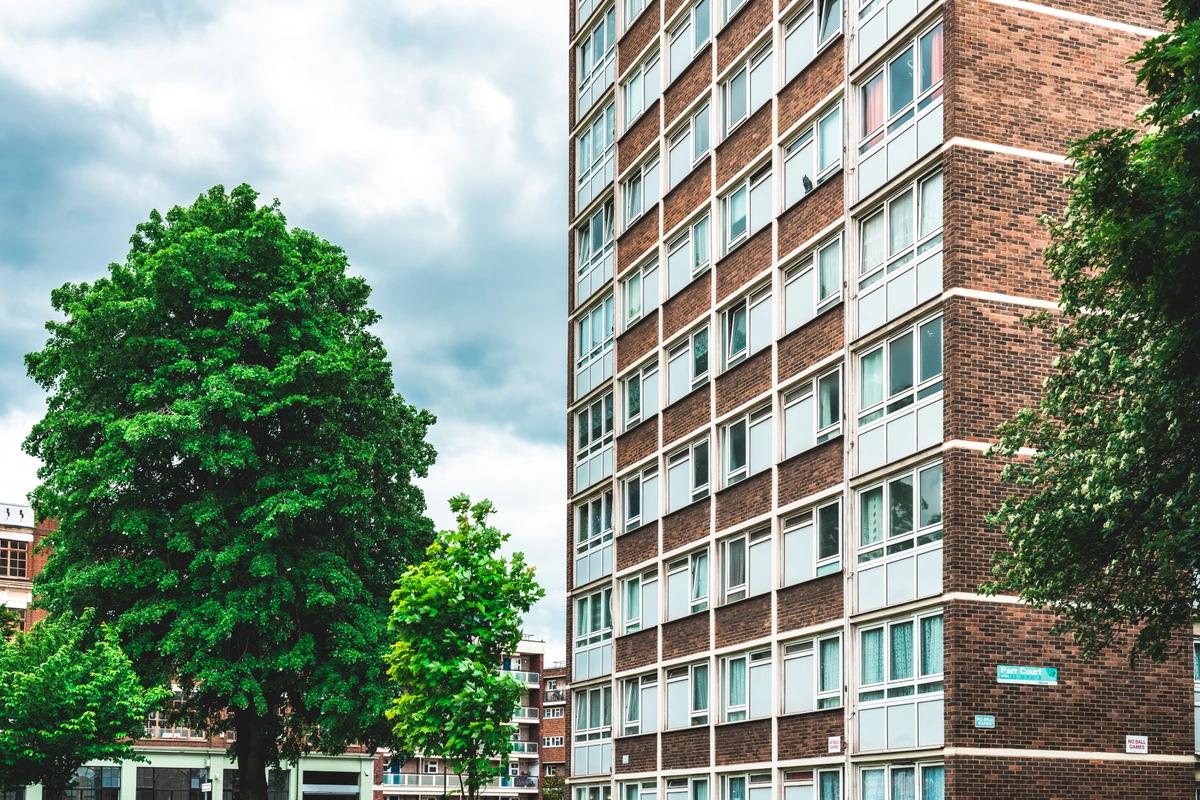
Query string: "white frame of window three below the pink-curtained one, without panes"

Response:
xmin=857 ymin=461 xmax=946 ymax=575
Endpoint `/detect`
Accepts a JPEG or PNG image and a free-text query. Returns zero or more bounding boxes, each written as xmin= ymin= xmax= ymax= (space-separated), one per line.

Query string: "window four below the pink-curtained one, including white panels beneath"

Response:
xmin=857 ymin=612 xmax=943 ymax=752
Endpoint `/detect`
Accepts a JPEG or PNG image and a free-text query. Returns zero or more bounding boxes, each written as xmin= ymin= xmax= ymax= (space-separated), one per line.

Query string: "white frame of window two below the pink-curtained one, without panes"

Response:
xmin=858 ymin=313 xmax=946 ymax=437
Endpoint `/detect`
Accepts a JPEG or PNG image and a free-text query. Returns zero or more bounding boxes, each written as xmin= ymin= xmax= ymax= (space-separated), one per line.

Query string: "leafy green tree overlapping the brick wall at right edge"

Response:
xmin=991 ymin=0 xmax=1200 ymax=657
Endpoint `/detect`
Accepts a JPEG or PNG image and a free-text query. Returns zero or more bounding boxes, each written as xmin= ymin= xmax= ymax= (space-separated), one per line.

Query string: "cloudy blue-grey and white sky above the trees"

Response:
xmin=0 ymin=0 xmax=568 ymax=657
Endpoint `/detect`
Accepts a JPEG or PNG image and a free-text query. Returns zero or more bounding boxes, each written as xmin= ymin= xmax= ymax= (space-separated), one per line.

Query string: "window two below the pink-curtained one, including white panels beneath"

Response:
xmin=858 ymin=317 xmax=942 ymax=471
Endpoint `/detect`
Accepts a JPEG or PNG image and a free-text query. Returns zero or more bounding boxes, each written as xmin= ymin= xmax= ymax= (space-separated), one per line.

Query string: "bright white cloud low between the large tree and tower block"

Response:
xmin=422 ymin=423 xmax=566 ymax=660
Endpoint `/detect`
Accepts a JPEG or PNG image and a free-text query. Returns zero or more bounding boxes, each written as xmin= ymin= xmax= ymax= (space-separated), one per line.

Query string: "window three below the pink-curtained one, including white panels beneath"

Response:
xmin=858 ymin=463 xmax=942 ymax=610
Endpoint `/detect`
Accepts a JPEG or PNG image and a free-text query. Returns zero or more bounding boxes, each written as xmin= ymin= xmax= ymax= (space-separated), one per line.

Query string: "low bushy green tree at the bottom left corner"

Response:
xmin=0 ymin=612 xmax=170 ymax=800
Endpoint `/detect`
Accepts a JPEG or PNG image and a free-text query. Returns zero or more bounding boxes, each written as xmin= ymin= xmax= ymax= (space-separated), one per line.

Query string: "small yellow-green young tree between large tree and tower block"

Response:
xmin=388 ymin=494 xmax=545 ymax=800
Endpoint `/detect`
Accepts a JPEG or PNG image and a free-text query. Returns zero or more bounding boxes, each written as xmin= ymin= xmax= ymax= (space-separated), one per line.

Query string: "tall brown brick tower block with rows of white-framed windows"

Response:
xmin=565 ymin=0 xmax=1185 ymax=800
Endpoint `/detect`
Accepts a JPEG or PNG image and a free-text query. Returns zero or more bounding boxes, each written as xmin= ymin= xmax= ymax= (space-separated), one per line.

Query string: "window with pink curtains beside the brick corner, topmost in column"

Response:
xmin=858 ymin=23 xmax=942 ymax=154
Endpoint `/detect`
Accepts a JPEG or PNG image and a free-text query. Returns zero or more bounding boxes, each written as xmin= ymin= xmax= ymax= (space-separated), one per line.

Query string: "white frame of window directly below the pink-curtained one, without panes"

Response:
xmin=858 ymin=168 xmax=944 ymax=307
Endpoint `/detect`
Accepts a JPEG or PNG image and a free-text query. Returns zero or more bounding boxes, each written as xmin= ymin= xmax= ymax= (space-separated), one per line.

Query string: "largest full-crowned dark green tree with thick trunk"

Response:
xmin=25 ymin=186 xmax=433 ymax=800
